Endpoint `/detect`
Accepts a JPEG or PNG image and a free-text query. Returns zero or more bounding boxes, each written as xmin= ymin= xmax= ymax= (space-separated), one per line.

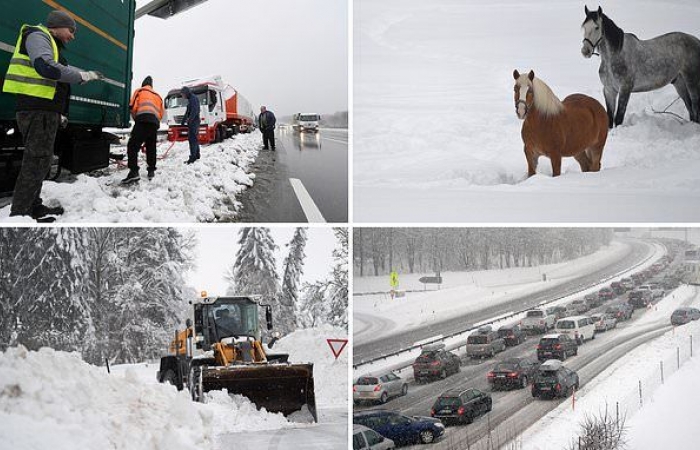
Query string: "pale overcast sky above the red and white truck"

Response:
xmin=133 ymin=0 xmax=348 ymax=116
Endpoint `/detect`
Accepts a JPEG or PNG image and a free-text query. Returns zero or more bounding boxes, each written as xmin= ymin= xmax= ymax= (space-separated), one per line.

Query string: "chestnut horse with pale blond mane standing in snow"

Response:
xmin=513 ymin=70 xmax=608 ymax=177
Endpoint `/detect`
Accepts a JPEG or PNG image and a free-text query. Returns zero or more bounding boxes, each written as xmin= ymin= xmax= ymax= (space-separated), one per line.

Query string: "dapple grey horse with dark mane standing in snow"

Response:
xmin=581 ymin=7 xmax=700 ymax=128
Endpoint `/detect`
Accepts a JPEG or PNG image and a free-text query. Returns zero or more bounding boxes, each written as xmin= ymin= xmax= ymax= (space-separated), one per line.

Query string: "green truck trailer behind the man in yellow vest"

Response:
xmin=0 ymin=0 xmax=206 ymax=192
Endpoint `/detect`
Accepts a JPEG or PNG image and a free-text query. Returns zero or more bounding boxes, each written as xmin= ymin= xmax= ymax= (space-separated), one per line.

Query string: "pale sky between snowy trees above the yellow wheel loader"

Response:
xmin=186 ymin=226 xmax=337 ymax=296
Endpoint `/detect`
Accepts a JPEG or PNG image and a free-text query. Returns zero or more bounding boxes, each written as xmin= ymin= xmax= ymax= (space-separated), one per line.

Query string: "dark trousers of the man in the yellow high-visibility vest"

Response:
xmin=10 ymin=111 xmax=61 ymax=215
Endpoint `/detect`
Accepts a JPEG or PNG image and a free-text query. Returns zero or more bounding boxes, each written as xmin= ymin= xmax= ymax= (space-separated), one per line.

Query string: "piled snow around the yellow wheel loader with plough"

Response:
xmin=0 ymin=326 xmax=348 ymax=450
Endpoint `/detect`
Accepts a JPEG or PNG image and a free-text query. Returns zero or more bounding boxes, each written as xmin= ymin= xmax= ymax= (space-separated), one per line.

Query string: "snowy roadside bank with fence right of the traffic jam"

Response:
xmin=521 ymin=286 xmax=700 ymax=450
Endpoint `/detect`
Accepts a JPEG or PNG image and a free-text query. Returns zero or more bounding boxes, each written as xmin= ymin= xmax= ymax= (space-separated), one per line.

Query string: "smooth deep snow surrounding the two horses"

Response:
xmin=353 ymin=0 xmax=700 ymax=222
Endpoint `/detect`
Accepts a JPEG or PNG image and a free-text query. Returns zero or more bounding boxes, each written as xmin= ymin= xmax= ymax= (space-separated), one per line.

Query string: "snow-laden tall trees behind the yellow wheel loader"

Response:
xmin=0 ymin=227 xmax=348 ymax=364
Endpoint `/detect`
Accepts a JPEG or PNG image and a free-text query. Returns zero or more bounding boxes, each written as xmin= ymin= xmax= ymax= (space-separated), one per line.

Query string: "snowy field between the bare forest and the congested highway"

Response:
xmin=353 ymin=241 xmax=665 ymax=346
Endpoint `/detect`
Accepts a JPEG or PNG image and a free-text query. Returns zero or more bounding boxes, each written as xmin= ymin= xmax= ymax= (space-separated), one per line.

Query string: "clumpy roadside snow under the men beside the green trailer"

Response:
xmin=0 ymin=133 xmax=262 ymax=224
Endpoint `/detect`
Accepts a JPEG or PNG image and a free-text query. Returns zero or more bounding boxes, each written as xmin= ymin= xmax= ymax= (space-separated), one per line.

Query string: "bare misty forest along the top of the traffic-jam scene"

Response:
xmin=353 ymin=228 xmax=613 ymax=276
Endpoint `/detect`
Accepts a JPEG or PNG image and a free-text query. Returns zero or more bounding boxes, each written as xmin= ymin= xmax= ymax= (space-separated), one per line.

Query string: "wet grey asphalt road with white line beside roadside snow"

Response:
xmin=238 ymin=128 xmax=348 ymax=223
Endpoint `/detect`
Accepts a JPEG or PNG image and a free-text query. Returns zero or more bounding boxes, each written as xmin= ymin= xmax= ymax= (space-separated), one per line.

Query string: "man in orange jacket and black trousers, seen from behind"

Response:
xmin=122 ymin=76 xmax=165 ymax=184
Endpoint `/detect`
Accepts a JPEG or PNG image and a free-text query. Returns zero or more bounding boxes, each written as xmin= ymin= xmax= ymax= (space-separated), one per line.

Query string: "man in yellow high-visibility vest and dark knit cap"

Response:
xmin=2 ymin=10 xmax=103 ymax=222
